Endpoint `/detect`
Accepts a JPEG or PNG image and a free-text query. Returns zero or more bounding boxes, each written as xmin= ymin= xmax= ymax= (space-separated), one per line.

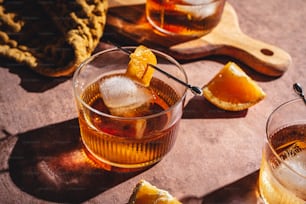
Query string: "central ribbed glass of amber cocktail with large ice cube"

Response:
xmin=73 ymin=47 xmax=187 ymax=171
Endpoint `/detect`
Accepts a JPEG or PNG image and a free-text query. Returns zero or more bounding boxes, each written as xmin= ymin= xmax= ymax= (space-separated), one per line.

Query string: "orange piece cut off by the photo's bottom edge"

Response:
xmin=128 ymin=180 xmax=181 ymax=204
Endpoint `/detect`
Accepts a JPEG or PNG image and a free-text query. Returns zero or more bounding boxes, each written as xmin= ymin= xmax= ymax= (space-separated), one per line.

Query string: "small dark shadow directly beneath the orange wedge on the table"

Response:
xmin=182 ymin=96 xmax=248 ymax=119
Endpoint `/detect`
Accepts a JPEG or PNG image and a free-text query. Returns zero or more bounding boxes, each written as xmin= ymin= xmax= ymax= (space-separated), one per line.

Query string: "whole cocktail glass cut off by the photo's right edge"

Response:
xmin=259 ymin=99 xmax=306 ymax=204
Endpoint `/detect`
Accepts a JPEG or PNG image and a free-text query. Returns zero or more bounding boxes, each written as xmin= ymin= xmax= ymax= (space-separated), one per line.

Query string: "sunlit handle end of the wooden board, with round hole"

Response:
xmin=170 ymin=3 xmax=291 ymax=76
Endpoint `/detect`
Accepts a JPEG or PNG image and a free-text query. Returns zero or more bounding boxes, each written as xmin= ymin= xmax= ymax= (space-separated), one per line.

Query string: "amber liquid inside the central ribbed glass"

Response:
xmin=79 ymin=74 xmax=181 ymax=171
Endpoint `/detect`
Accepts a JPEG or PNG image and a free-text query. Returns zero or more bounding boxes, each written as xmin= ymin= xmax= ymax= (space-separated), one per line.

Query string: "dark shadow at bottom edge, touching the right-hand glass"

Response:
xmin=181 ymin=170 xmax=262 ymax=204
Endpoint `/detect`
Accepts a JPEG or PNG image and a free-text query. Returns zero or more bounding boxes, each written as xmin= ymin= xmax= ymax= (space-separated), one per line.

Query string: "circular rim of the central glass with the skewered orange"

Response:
xmin=72 ymin=46 xmax=188 ymax=121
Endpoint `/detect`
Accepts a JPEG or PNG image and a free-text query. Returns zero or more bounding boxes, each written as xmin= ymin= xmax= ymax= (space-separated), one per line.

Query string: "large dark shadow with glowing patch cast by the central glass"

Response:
xmin=9 ymin=119 xmax=146 ymax=203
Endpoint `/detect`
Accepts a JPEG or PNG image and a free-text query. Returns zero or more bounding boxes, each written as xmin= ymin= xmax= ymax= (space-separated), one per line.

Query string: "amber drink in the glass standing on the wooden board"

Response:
xmin=146 ymin=0 xmax=225 ymax=37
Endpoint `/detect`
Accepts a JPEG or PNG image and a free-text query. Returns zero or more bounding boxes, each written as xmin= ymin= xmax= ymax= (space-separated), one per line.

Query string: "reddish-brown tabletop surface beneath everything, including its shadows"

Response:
xmin=0 ymin=0 xmax=306 ymax=203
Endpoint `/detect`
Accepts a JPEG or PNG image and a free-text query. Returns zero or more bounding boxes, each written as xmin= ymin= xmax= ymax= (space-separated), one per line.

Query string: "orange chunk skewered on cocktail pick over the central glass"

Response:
xmin=126 ymin=45 xmax=157 ymax=87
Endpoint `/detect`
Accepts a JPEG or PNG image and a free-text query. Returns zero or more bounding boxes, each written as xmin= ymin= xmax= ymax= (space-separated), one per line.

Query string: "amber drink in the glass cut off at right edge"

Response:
xmin=259 ymin=125 xmax=306 ymax=204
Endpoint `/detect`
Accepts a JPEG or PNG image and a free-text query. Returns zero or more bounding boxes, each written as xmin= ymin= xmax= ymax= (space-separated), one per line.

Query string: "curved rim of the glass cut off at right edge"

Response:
xmin=266 ymin=98 xmax=306 ymax=179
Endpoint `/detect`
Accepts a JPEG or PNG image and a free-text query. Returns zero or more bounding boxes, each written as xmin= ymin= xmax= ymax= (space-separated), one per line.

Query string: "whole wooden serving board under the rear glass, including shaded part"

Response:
xmin=107 ymin=3 xmax=291 ymax=76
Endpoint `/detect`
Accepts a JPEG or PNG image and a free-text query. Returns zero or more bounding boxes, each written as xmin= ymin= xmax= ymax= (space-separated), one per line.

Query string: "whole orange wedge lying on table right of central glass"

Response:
xmin=203 ymin=62 xmax=266 ymax=111
